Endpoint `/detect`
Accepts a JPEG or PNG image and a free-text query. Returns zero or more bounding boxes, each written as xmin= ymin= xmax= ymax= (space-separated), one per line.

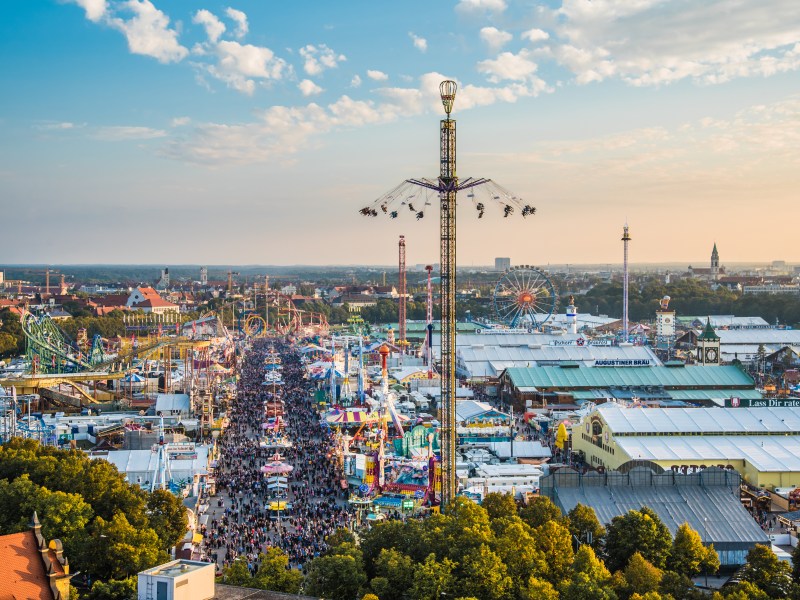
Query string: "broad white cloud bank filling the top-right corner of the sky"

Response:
xmin=549 ymin=0 xmax=800 ymax=86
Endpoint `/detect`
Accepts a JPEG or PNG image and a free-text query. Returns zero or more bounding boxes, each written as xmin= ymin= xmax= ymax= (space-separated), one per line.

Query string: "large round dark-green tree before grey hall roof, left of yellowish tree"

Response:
xmin=605 ymin=507 xmax=672 ymax=571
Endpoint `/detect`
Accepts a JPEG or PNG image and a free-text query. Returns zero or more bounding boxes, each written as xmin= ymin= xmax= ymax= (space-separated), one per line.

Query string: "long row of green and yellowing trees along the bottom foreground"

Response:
xmin=219 ymin=494 xmax=800 ymax=600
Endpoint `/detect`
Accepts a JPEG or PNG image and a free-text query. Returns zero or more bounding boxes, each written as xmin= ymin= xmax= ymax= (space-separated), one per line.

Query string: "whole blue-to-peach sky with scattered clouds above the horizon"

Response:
xmin=0 ymin=0 xmax=800 ymax=266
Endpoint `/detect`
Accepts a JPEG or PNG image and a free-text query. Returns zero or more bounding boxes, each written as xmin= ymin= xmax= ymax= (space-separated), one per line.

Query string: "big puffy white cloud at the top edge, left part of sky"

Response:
xmin=108 ymin=0 xmax=189 ymax=63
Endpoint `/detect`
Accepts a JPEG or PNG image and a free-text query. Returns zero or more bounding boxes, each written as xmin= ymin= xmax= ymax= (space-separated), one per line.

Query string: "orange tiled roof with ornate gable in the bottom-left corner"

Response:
xmin=0 ymin=531 xmax=54 ymax=600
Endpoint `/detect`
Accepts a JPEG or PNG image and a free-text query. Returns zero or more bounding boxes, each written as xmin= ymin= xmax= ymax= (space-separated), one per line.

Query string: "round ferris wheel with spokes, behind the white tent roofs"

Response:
xmin=492 ymin=265 xmax=558 ymax=329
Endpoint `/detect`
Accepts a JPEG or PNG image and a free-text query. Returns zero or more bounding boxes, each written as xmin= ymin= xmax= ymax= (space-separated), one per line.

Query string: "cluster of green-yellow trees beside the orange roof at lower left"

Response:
xmin=0 ymin=438 xmax=187 ymax=580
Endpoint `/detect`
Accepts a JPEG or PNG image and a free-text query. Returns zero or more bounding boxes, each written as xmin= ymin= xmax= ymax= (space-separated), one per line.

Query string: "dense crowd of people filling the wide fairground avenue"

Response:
xmin=204 ymin=339 xmax=352 ymax=573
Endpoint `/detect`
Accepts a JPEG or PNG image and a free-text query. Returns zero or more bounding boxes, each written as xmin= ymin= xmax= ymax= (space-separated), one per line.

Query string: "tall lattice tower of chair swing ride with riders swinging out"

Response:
xmin=359 ymin=80 xmax=536 ymax=507
